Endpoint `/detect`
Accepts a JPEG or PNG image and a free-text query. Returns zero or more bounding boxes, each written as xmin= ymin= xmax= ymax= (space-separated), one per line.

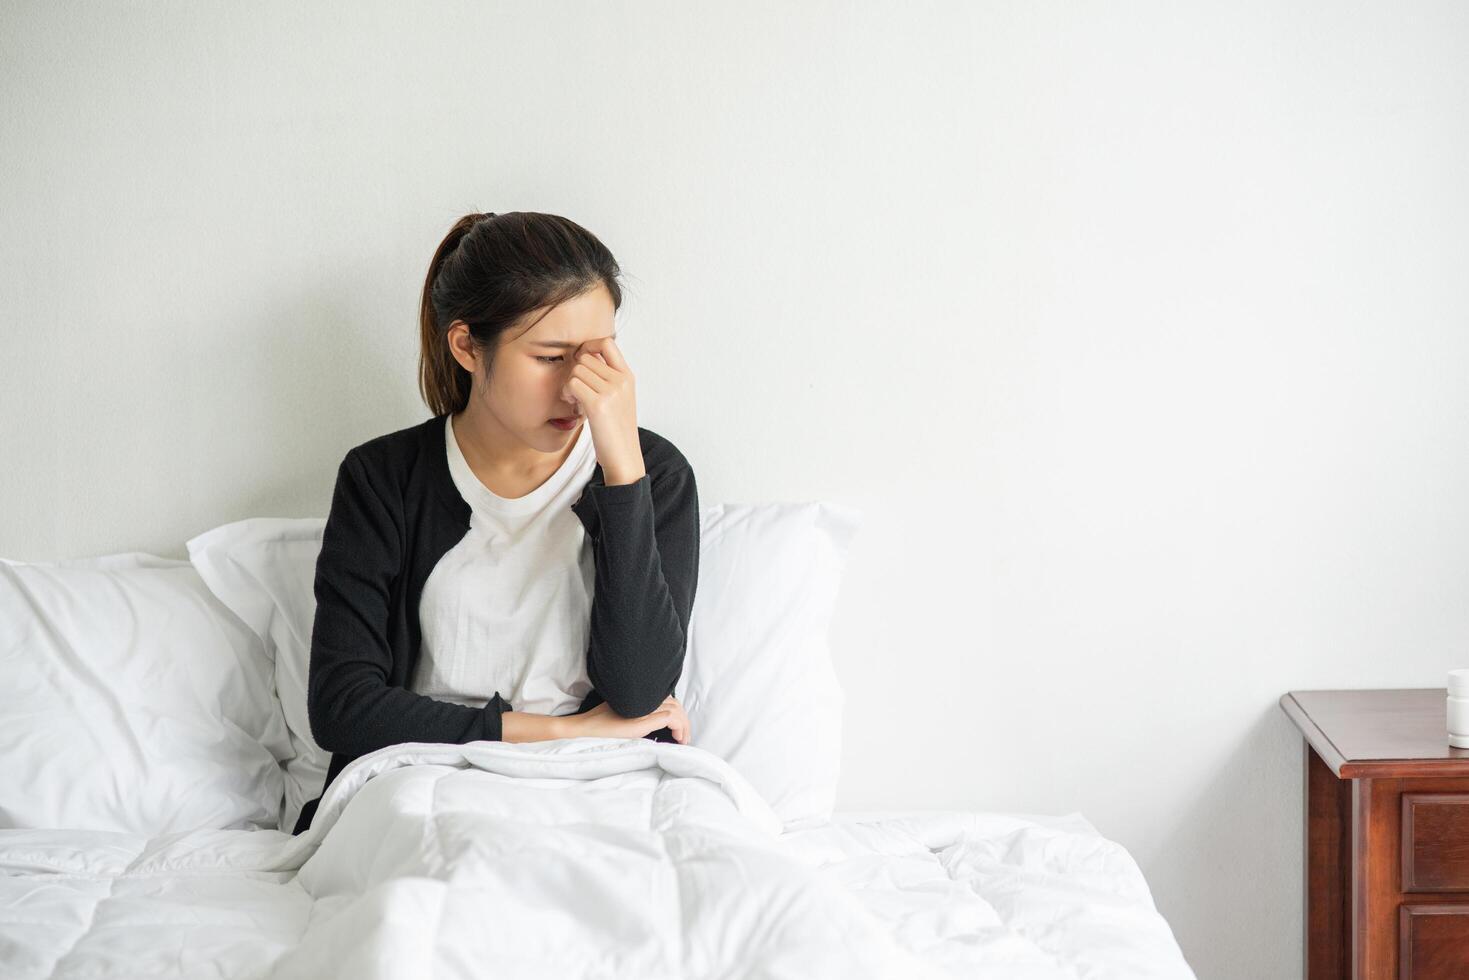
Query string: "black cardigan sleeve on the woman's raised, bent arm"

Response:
xmin=574 ymin=455 xmax=699 ymax=718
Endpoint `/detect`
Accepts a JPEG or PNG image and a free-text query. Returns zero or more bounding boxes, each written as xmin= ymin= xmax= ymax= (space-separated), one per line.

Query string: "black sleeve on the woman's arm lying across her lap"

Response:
xmin=307 ymin=450 xmax=510 ymax=757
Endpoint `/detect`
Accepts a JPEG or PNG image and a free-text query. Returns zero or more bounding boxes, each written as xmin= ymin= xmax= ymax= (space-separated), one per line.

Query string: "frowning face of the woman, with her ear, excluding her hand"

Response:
xmin=450 ymin=284 xmax=616 ymax=453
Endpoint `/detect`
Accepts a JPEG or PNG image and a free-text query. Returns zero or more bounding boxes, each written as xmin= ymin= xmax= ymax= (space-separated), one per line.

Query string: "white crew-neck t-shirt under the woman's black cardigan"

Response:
xmin=410 ymin=413 xmax=596 ymax=714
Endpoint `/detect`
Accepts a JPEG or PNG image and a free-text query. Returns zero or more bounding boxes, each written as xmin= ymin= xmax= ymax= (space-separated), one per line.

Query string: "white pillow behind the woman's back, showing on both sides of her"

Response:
xmin=188 ymin=502 xmax=861 ymax=829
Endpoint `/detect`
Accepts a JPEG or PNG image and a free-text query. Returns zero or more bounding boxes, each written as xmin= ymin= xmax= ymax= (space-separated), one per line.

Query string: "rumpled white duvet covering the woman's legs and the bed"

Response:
xmin=0 ymin=738 xmax=1193 ymax=980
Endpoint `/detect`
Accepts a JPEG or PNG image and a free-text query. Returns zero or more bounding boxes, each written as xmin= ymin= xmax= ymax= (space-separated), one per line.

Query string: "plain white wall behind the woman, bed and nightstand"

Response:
xmin=0 ymin=0 xmax=1469 ymax=980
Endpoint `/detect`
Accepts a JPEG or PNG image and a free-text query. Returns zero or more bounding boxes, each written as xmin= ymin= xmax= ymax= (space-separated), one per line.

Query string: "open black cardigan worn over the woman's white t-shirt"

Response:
xmin=292 ymin=416 xmax=699 ymax=835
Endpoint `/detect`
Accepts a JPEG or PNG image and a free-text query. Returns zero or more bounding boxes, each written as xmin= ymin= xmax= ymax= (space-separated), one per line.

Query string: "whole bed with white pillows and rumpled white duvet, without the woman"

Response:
xmin=0 ymin=504 xmax=1194 ymax=980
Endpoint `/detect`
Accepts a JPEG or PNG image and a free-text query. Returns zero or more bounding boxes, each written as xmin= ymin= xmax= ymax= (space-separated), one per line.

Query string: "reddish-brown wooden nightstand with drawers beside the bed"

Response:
xmin=1281 ymin=688 xmax=1469 ymax=980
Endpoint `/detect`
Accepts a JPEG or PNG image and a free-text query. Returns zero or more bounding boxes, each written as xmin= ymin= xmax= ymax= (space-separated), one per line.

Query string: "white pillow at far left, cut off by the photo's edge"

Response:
xmin=0 ymin=552 xmax=289 ymax=836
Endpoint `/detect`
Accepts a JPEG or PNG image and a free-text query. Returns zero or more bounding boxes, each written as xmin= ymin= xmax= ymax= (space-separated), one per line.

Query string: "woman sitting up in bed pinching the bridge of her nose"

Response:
xmin=294 ymin=212 xmax=699 ymax=833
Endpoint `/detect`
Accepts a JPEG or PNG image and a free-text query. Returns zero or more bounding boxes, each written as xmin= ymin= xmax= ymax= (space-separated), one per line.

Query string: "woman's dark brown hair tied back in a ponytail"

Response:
xmin=419 ymin=212 xmax=623 ymax=416
